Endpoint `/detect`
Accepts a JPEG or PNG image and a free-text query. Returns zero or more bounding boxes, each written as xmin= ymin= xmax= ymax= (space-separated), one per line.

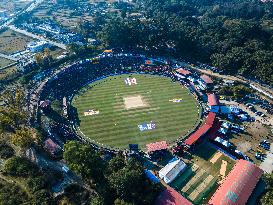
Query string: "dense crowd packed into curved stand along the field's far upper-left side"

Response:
xmin=41 ymin=55 xmax=172 ymax=100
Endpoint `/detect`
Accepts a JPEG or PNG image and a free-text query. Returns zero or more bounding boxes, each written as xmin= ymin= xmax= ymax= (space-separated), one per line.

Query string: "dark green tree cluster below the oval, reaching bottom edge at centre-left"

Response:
xmin=64 ymin=141 xmax=161 ymax=205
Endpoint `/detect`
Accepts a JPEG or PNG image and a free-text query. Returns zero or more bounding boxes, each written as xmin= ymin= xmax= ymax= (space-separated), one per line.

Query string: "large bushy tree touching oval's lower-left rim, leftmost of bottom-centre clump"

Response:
xmin=64 ymin=141 xmax=105 ymax=181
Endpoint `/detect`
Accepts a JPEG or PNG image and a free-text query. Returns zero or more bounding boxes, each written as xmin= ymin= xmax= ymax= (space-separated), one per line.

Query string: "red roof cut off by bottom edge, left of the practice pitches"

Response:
xmin=154 ymin=187 xmax=193 ymax=205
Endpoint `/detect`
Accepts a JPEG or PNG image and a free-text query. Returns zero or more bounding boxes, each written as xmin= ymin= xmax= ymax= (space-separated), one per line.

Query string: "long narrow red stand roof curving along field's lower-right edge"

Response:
xmin=185 ymin=112 xmax=216 ymax=146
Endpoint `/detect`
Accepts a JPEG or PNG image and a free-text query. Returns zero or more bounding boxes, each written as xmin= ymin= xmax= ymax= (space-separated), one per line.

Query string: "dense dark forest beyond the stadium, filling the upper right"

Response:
xmin=100 ymin=0 xmax=273 ymax=85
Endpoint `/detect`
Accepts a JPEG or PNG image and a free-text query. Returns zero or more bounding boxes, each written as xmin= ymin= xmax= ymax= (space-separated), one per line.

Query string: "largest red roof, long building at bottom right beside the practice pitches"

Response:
xmin=208 ymin=160 xmax=263 ymax=205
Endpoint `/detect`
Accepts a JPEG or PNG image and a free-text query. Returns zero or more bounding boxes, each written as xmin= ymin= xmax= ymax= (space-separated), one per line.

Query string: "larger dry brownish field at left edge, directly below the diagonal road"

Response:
xmin=0 ymin=30 xmax=33 ymax=55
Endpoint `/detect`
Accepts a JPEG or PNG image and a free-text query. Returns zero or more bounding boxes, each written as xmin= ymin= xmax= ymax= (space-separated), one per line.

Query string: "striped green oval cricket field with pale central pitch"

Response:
xmin=72 ymin=74 xmax=199 ymax=148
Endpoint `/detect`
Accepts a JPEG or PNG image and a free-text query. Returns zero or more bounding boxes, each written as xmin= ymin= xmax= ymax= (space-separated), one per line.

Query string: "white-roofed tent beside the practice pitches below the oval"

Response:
xmin=159 ymin=159 xmax=187 ymax=184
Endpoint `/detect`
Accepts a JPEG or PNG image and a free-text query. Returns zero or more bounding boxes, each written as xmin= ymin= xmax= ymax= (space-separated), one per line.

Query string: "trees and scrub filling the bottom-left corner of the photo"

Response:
xmin=0 ymin=156 xmax=54 ymax=205
